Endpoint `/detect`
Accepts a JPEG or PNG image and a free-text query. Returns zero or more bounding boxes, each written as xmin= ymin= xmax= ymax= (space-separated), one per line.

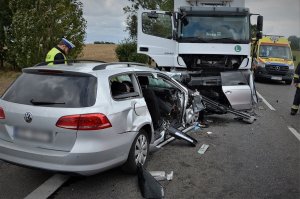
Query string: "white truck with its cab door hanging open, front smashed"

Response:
xmin=137 ymin=0 xmax=262 ymax=110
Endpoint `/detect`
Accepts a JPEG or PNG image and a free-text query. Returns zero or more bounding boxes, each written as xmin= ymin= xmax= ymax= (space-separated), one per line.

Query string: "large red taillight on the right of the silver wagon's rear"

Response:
xmin=56 ymin=113 xmax=111 ymax=130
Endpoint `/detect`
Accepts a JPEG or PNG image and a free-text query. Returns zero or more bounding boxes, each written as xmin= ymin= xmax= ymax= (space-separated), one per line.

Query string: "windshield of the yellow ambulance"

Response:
xmin=259 ymin=45 xmax=292 ymax=59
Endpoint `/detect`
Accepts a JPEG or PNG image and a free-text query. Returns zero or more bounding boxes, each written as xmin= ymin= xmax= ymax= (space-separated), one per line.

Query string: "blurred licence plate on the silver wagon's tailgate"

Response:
xmin=14 ymin=128 xmax=51 ymax=143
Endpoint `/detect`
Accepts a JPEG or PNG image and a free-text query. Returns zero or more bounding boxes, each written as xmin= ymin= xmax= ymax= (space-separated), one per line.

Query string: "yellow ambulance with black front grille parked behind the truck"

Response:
xmin=252 ymin=35 xmax=295 ymax=84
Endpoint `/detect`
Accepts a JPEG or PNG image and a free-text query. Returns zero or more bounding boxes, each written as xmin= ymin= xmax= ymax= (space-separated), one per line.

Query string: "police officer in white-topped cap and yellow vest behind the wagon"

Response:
xmin=45 ymin=38 xmax=75 ymax=65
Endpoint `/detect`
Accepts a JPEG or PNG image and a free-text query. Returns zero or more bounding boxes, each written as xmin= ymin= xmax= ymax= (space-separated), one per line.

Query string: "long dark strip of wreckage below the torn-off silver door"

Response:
xmin=202 ymin=96 xmax=256 ymax=124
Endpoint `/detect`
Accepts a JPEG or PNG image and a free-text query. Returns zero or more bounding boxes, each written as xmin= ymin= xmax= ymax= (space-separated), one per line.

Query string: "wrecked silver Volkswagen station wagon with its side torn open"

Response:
xmin=0 ymin=61 xmax=199 ymax=175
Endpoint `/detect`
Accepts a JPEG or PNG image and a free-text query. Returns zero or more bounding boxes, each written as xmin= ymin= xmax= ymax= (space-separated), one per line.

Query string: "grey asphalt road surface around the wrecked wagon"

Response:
xmin=0 ymin=79 xmax=300 ymax=199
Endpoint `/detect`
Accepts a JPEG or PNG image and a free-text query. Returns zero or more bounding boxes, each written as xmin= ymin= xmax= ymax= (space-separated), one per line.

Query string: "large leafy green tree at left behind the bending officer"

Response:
xmin=0 ymin=0 xmax=86 ymax=70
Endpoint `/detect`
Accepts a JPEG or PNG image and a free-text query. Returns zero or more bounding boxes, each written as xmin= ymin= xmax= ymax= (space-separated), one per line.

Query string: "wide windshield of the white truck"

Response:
xmin=180 ymin=16 xmax=250 ymax=43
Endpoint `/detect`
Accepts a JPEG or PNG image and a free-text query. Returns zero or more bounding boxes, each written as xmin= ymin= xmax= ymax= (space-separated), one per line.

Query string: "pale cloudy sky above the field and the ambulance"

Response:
xmin=81 ymin=0 xmax=300 ymax=43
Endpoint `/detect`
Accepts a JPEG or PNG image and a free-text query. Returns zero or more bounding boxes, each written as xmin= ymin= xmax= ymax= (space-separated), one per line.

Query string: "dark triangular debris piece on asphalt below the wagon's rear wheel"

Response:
xmin=137 ymin=164 xmax=164 ymax=198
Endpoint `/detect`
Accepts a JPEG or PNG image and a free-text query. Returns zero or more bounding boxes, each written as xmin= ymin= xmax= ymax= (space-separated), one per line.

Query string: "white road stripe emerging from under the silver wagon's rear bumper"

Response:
xmin=25 ymin=174 xmax=70 ymax=199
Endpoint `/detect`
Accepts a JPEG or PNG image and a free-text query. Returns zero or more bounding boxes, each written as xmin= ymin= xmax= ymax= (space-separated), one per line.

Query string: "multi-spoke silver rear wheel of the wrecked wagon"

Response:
xmin=122 ymin=129 xmax=149 ymax=174
